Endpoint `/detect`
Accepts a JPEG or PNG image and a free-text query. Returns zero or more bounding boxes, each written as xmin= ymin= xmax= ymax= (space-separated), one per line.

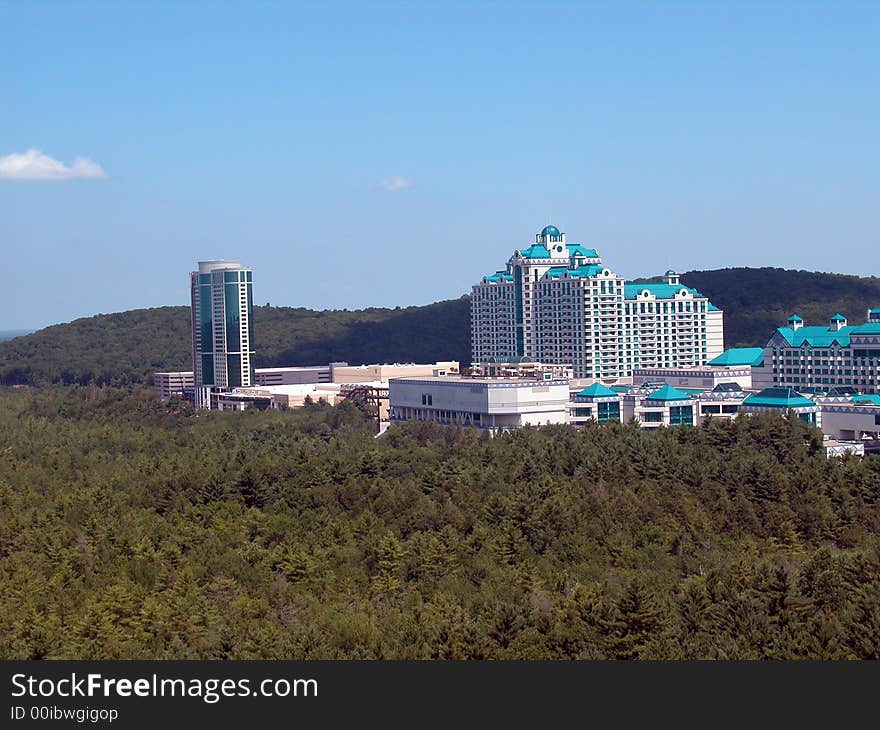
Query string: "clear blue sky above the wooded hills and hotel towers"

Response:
xmin=0 ymin=0 xmax=880 ymax=329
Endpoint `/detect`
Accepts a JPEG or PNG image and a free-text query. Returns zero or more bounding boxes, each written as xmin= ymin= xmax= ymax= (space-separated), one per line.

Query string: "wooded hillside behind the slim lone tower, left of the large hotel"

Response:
xmin=0 ymin=297 xmax=470 ymax=385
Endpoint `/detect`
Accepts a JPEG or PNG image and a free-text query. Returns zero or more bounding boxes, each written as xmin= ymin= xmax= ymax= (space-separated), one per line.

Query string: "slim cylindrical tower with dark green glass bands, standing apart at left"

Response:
xmin=190 ymin=261 xmax=254 ymax=408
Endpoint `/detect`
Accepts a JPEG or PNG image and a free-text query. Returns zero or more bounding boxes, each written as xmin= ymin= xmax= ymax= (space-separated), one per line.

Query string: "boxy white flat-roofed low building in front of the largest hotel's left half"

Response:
xmin=388 ymin=376 xmax=569 ymax=432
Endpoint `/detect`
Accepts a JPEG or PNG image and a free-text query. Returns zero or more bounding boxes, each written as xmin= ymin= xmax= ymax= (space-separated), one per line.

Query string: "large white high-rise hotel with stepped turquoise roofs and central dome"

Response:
xmin=471 ymin=226 xmax=724 ymax=379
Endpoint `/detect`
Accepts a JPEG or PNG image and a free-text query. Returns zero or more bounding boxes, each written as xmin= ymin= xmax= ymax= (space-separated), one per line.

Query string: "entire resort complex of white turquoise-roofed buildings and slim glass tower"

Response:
xmin=168 ymin=239 xmax=880 ymax=454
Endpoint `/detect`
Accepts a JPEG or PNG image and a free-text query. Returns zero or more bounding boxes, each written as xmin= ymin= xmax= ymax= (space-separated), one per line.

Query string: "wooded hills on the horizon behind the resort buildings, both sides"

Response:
xmin=0 ymin=268 xmax=880 ymax=386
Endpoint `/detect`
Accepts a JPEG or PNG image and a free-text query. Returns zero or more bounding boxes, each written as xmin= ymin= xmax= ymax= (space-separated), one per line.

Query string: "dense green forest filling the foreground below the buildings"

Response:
xmin=0 ymin=385 xmax=880 ymax=659
